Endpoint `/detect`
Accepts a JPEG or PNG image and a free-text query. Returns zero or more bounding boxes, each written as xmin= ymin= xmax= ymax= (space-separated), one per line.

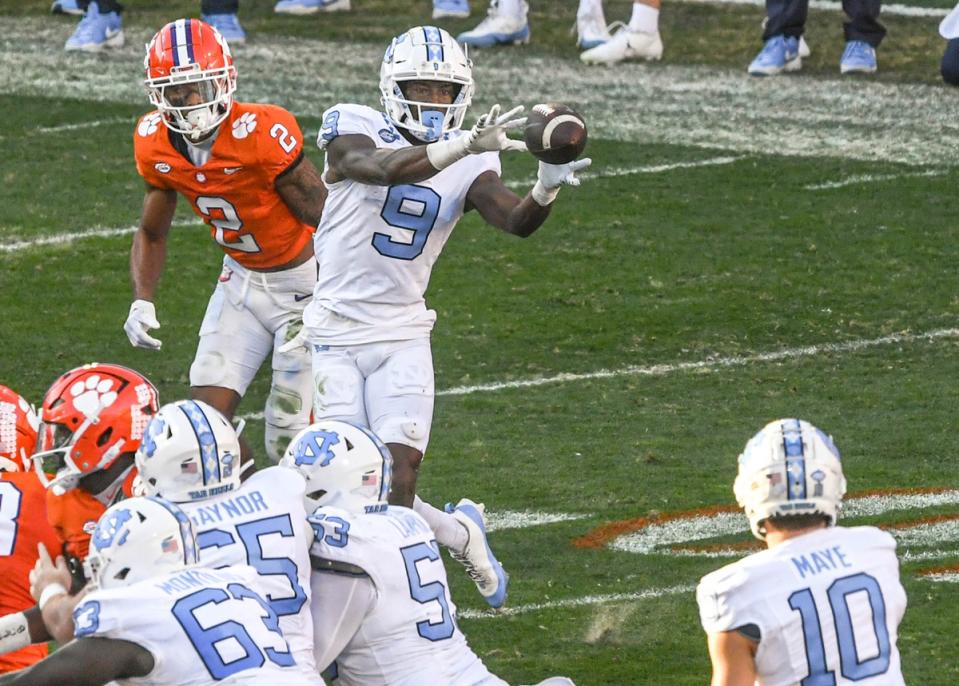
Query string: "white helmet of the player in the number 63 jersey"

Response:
xmin=84 ymin=498 xmax=198 ymax=588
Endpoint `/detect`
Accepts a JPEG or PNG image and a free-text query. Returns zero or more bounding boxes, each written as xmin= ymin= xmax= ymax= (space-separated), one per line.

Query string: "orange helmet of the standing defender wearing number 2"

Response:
xmin=143 ymin=19 xmax=236 ymax=140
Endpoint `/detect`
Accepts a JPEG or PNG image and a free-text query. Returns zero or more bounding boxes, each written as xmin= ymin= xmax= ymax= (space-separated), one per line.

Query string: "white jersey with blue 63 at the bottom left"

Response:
xmin=73 ymin=566 xmax=321 ymax=686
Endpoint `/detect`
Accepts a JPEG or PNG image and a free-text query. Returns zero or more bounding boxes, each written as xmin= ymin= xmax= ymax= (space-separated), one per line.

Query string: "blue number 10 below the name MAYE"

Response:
xmin=789 ymin=572 xmax=892 ymax=686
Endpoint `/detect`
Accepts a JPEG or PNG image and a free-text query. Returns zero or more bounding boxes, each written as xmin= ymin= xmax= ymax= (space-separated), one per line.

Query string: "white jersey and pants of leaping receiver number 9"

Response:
xmin=303 ymin=104 xmax=500 ymax=451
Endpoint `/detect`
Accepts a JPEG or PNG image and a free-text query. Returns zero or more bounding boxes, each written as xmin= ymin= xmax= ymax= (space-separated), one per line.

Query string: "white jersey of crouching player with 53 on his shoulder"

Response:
xmin=310 ymin=505 xmax=506 ymax=686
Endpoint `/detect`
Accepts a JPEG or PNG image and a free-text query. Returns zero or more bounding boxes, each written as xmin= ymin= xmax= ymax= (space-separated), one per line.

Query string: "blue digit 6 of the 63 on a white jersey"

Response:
xmin=173 ymin=584 xmax=266 ymax=681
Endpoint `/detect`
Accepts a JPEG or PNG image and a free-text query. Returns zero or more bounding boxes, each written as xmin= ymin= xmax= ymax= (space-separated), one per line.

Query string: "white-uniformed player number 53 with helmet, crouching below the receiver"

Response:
xmin=280 ymin=420 xmax=572 ymax=686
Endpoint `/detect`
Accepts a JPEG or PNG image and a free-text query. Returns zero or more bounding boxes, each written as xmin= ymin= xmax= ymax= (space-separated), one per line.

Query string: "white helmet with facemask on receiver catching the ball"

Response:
xmin=380 ymin=26 xmax=473 ymax=142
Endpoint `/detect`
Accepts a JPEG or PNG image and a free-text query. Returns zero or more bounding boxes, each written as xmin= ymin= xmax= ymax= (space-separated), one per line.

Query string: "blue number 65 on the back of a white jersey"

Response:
xmin=197 ymin=515 xmax=306 ymax=617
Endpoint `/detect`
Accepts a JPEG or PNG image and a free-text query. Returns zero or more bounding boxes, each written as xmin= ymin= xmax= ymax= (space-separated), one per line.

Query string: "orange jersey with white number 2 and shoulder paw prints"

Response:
xmin=133 ymin=102 xmax=313 ymax=270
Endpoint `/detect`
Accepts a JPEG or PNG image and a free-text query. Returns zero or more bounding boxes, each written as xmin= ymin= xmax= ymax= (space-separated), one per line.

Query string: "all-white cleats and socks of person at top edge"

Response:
xmin=576 ymin=0 xmax=663 ymax=64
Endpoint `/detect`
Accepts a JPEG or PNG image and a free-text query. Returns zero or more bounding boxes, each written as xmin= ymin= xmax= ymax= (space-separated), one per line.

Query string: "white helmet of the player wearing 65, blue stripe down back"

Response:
xmin=136 ymin=400 xmax=240 ymax=503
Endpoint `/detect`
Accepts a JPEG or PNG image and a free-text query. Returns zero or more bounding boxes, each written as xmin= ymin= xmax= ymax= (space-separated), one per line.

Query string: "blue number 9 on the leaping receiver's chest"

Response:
xmin=373 ymin=184 xmax=440 ymax=260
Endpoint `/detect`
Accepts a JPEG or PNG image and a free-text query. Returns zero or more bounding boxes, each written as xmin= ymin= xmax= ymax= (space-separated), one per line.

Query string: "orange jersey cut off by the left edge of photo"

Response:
xmin=0 ymin=472 xmax=60 ymax=673
